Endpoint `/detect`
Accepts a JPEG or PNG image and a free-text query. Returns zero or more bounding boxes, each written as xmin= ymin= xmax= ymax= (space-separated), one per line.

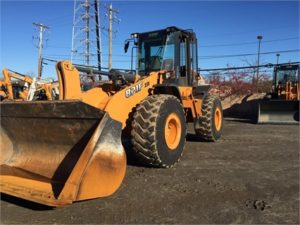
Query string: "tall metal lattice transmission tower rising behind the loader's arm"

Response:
xmin=71 ymin=0 xmax=101 ymax=70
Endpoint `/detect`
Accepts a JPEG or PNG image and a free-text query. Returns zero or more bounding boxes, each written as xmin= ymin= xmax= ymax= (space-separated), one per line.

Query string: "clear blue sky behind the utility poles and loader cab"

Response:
xmin=0 ymin=0 xmax=300 ymax=77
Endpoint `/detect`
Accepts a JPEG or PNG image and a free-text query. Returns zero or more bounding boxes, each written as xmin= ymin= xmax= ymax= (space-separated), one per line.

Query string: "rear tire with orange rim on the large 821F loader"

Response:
xmin=194 ymin=95 xmax=223 ymax=141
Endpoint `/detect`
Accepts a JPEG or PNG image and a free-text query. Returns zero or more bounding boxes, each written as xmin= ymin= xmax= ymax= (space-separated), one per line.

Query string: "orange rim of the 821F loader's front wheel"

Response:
xmin=165 ymin=113 xmax=181 ymax=150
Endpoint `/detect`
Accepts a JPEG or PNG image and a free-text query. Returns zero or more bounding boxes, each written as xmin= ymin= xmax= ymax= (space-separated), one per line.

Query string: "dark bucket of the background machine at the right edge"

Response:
xmin=257 ymin=100 xmax=299 ymax=124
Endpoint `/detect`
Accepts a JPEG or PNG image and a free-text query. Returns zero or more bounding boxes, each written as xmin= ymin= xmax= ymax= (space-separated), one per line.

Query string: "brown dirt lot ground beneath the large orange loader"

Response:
xmin=1 ymin=119 xmax=299 ymax=224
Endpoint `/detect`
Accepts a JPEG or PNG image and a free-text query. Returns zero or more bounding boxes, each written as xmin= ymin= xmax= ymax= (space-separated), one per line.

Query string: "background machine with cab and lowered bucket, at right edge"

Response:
xmin=257 ymin=64 xmax=300 ymax=124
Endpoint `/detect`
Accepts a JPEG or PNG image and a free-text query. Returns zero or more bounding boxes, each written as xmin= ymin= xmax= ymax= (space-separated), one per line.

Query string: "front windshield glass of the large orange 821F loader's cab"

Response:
xmin=138 ymin=32 xmax=175 ymax=75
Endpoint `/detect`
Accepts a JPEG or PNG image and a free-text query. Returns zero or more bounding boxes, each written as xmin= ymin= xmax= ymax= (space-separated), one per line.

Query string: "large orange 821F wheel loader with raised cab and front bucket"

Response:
xmin=0 ymin=27 xmax=223 ymax=206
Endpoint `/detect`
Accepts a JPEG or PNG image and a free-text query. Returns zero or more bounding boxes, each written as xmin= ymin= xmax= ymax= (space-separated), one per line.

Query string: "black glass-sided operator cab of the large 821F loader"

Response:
xmin=124 ymin=27 xmax=198 ymax=86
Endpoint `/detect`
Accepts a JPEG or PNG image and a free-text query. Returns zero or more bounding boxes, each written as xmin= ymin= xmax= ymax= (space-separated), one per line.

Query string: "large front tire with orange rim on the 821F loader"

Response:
xmin=131 ymin=95 xmax=186 ymax=168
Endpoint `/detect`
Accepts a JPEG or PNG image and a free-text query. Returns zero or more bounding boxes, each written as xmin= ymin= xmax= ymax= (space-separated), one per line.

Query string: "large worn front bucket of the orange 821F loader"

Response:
xmin=0 ymin=101 xmax=126 ymax=206
